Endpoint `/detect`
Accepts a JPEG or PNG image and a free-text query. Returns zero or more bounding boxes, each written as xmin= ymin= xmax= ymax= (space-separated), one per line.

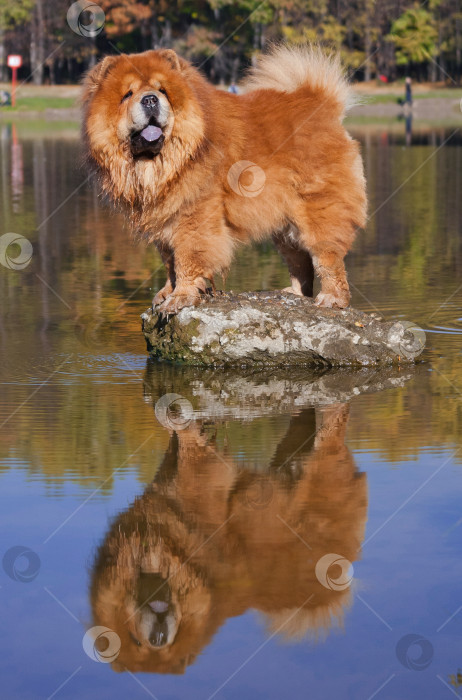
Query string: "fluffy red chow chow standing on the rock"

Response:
xmin=83 ymin=45 xmax=366 ymax=313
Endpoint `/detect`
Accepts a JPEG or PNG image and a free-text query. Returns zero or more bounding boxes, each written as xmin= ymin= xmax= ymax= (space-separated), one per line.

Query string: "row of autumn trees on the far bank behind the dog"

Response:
xmin=0 ymin=0 xmax=462 ymax=84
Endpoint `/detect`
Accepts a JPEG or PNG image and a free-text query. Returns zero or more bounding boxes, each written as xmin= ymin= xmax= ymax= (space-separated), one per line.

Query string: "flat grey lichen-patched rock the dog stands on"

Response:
xmin=141 ymin=292 xmax=425 ymax=368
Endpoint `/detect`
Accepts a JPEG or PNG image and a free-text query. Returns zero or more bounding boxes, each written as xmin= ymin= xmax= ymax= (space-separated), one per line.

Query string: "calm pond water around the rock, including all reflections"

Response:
xmin=0 ymin=125 xmax=462 ymax=700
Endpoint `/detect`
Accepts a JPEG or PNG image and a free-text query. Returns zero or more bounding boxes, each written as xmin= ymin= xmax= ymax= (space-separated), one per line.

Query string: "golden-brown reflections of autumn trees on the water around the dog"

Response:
xmin=0 ymin=133 xmax=462 ymax=478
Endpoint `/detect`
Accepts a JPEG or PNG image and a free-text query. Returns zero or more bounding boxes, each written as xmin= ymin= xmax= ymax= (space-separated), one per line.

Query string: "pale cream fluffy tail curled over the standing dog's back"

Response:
xmin=245 ymin=44 xmax=359 ymax=115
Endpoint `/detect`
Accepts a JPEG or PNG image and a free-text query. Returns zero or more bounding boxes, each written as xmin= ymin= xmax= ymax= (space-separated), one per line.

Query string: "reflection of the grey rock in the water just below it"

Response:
xmin=144 ymin=362 xmax=415 ymax=420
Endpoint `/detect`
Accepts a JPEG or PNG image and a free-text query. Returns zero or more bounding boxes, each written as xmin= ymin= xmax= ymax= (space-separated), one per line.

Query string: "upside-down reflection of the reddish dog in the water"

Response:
xmin=91 ymin=405 xmax=367 ymax=673
